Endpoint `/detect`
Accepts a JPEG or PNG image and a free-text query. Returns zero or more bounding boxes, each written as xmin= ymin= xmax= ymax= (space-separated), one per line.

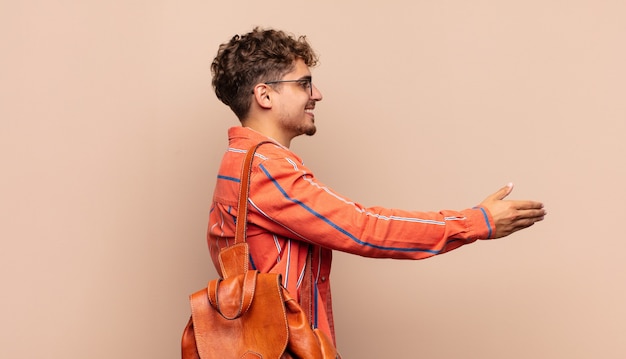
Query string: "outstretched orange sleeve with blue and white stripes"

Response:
xmin=248 ymin=156 xmax=494 ymax=259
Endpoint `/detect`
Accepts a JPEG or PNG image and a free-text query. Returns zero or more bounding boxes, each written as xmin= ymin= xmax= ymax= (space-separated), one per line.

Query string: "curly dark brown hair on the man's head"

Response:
xmin=211 ymin=27 xmax=318 ymax=120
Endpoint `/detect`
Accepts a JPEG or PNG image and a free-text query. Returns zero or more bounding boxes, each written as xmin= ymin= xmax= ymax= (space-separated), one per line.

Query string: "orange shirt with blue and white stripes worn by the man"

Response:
xmin=207 ymin=127 xmax=494 ymax=340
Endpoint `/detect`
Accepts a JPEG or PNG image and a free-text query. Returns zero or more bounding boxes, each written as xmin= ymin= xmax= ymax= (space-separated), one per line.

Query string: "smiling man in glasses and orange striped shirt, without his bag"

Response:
xmin=208 ymin=28 xmax=546 ymax=346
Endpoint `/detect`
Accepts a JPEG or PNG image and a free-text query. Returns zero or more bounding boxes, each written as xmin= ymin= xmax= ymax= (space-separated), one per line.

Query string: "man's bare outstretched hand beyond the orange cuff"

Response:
xmin=480 ymin=183 xmax=547 ymax=238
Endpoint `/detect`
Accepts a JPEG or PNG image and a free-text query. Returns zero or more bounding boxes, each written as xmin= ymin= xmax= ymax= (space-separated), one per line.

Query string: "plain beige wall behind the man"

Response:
xmin=0 ymin=0 xmax=626 ymax=359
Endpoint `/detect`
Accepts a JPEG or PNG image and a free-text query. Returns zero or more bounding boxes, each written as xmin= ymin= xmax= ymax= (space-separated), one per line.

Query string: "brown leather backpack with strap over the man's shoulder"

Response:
xmin=181 ymin=142 xmax=340 ymax=359
